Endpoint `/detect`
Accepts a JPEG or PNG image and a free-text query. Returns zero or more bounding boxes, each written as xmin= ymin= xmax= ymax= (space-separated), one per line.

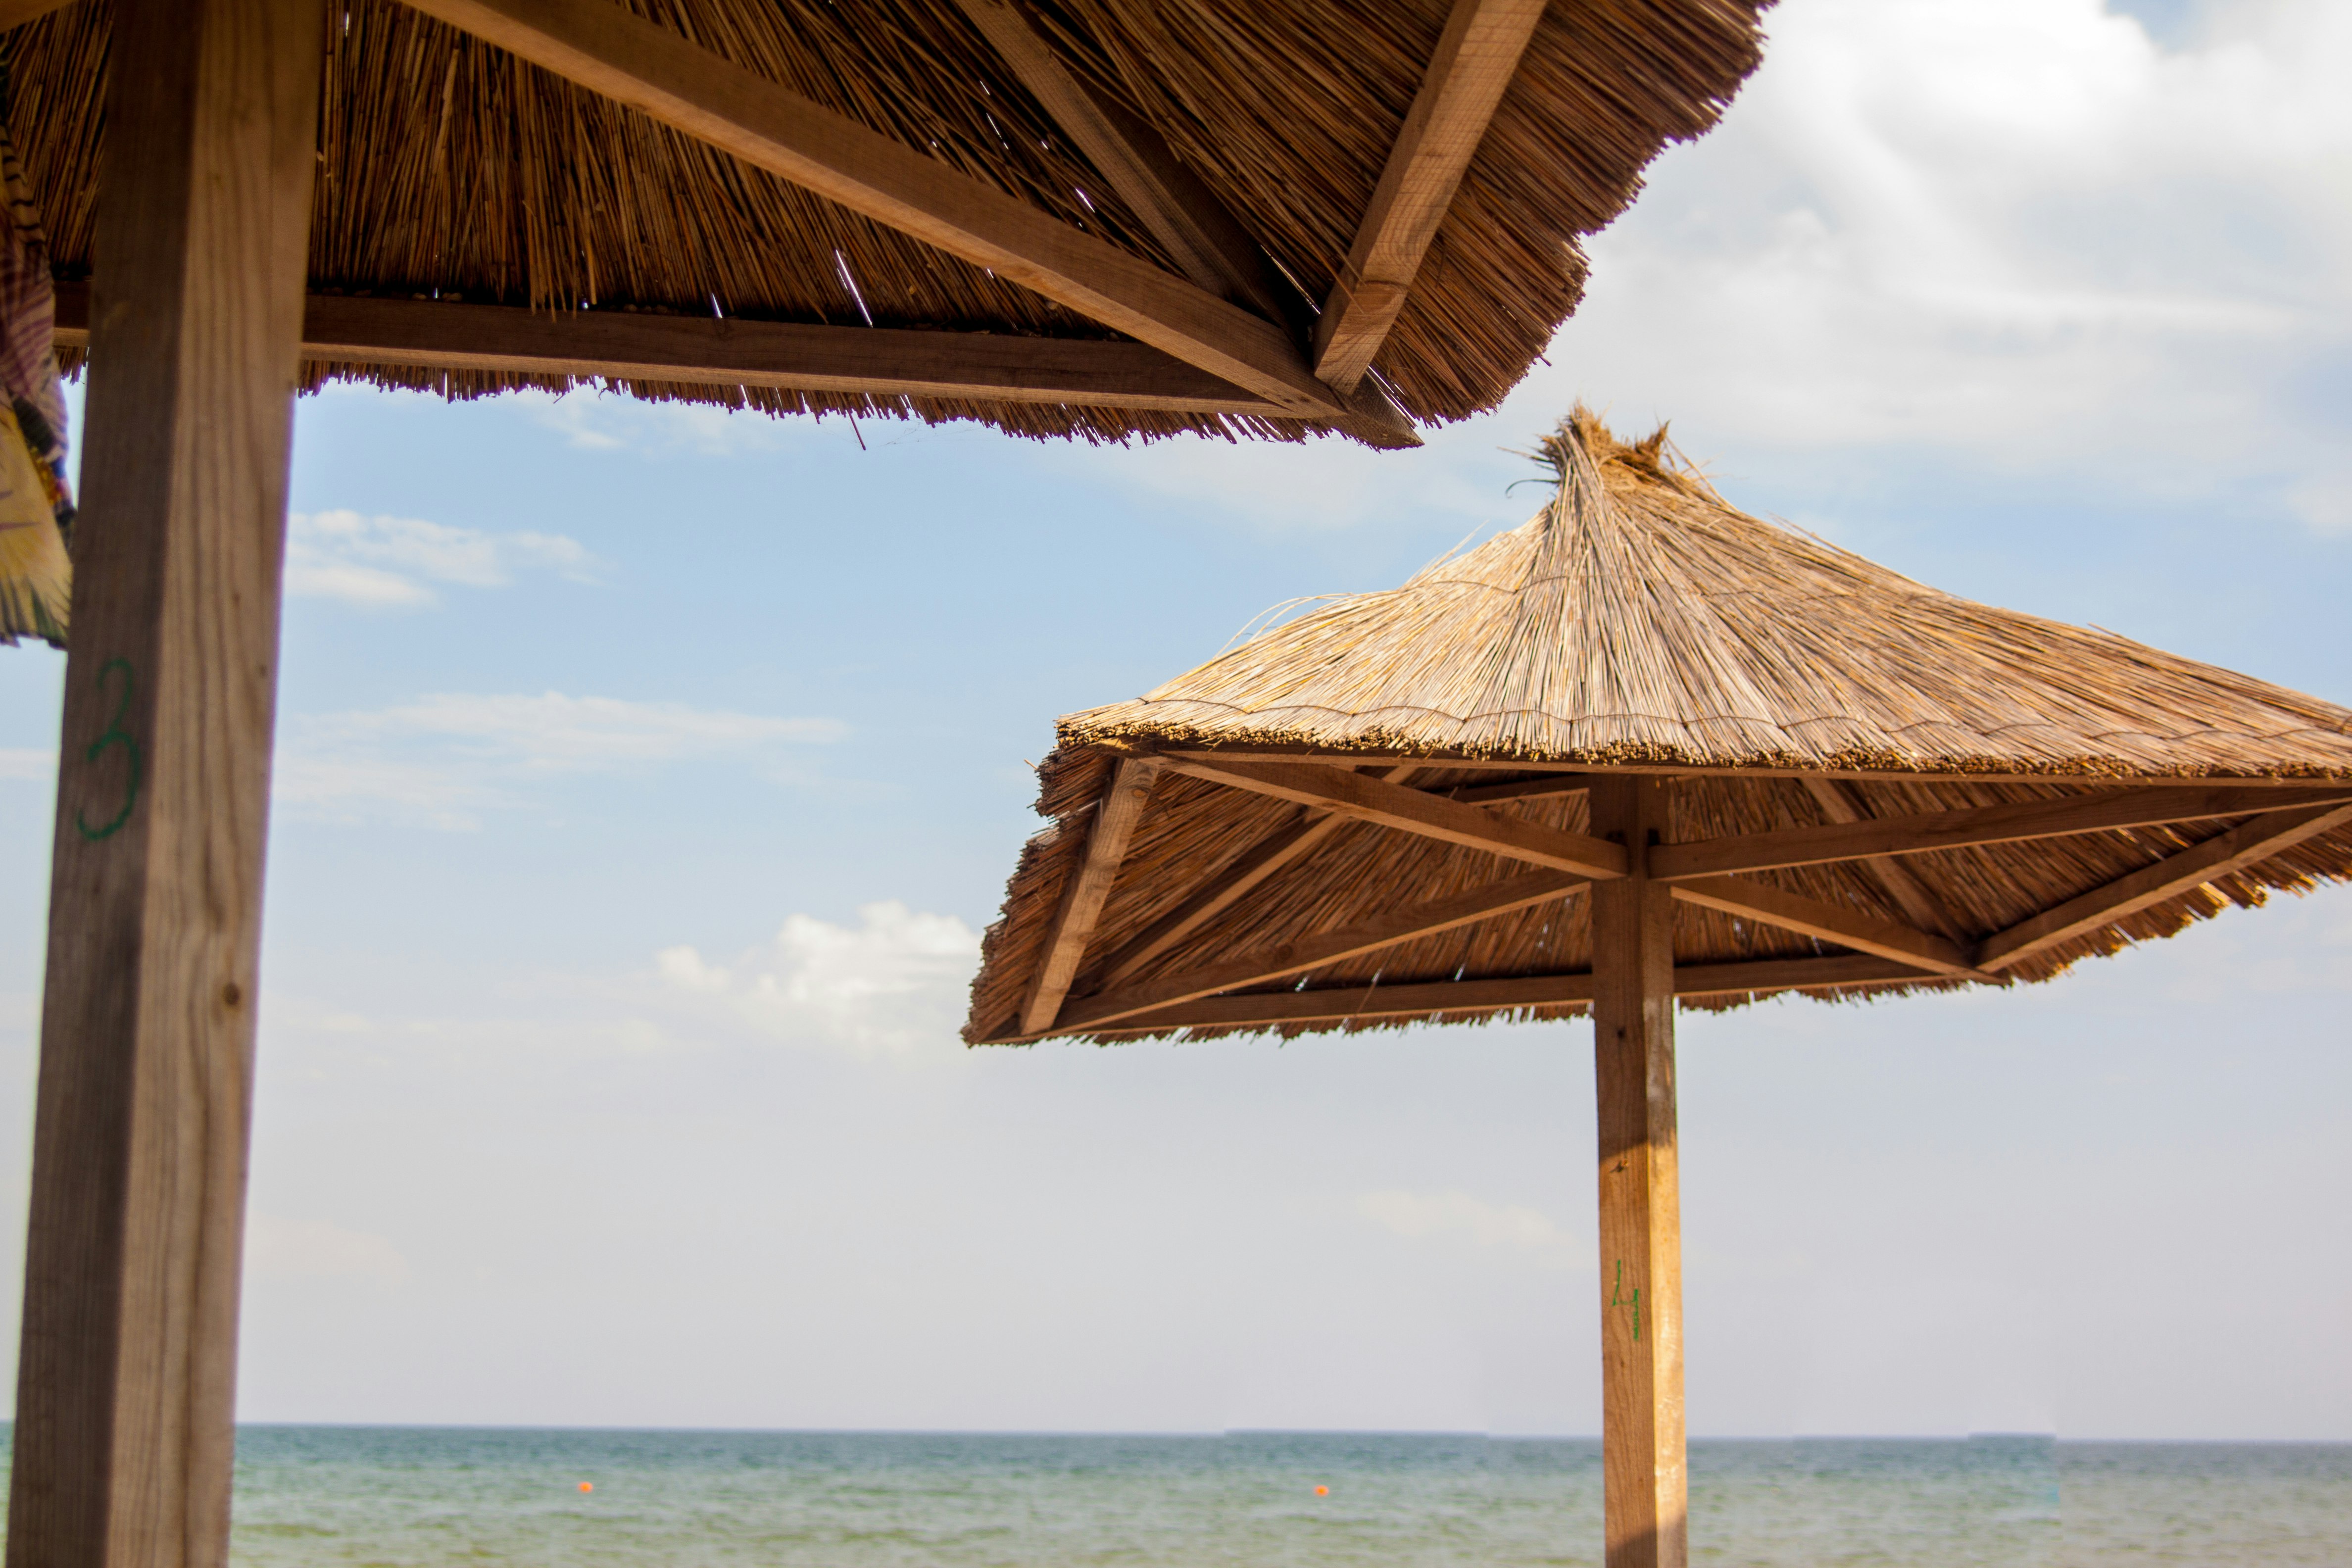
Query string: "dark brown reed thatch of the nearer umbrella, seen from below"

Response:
xmin=7 ymin=0 xmax=1769 ymax=440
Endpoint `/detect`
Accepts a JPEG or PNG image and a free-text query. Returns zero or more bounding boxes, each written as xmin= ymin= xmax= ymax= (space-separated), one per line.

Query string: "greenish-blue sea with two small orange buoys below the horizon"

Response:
xmin=4 ymin=1427 xmax=2352 ymax=1568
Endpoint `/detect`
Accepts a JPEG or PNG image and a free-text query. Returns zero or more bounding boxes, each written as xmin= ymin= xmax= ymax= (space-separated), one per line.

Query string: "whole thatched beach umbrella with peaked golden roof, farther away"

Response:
xmin=964 ymin=409 xmax=2352 ymax=1568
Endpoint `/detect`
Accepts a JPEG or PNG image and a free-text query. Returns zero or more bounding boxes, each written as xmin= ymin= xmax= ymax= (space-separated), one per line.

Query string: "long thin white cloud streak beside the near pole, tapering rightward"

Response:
xmin=278 ymin=691 xmax=847 ymax=828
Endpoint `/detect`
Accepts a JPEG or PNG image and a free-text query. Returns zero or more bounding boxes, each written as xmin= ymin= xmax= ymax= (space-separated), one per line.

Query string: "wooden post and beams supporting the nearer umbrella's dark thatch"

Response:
xmin=0 ymin=0 xmax=1618 ymax=1568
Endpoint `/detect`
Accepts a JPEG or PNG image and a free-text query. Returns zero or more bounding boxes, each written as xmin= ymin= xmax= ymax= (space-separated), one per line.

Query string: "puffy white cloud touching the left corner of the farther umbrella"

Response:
xmin=656 ymin=900 xmax=981 ymax=1051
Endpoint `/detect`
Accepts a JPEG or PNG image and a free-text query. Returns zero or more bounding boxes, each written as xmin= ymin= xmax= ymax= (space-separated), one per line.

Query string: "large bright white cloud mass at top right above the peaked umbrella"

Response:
xmin=1091 ymin=0 xmax=2352 ymax=531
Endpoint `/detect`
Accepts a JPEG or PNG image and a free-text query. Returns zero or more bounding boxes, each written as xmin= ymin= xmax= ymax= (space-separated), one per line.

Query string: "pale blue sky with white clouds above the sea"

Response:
xmin=0 ymin=0 xmax=2352 ymax=1439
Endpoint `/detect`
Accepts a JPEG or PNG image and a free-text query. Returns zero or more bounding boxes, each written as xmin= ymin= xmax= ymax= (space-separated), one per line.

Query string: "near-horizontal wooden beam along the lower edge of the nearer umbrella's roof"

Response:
xmin=56 ymin=282 xmax=1286 ymax=418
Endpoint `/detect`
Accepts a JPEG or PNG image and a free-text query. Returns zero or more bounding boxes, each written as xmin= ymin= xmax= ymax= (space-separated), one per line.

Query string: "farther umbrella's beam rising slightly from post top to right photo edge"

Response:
xmin=1651 ymin=783 xmax=2352 ymax=882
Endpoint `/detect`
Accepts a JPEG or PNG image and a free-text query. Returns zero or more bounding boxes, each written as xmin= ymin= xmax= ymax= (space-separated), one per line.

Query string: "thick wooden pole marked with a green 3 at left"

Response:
xmin=7 ymin=0 xmax=325 ymax=1568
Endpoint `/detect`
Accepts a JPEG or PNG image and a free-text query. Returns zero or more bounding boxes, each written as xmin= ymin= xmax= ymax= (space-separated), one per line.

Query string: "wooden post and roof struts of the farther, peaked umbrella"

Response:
xmin=974 ymin=747 xmax=2352 ymax=1568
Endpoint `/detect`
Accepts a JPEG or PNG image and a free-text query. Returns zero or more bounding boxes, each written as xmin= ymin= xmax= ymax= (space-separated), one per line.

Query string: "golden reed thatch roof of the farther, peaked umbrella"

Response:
xmin=964 ymin=409 xmax=2352 ymax=1044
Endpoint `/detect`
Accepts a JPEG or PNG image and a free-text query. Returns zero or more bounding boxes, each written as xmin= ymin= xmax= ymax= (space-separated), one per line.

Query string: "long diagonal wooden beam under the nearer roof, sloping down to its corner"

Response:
xmin=409 ymin=0 xmax=1355 ymax=421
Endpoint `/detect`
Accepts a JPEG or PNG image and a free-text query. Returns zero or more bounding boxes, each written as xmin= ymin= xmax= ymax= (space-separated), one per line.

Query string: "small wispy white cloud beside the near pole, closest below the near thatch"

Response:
xmin=287 ymin=510 xmax=593 ymax=606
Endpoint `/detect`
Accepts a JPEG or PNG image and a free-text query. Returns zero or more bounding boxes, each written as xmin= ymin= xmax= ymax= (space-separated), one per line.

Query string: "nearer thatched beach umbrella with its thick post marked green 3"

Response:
xmin=0 ymin=0 xmax=1764 ymax=1568
